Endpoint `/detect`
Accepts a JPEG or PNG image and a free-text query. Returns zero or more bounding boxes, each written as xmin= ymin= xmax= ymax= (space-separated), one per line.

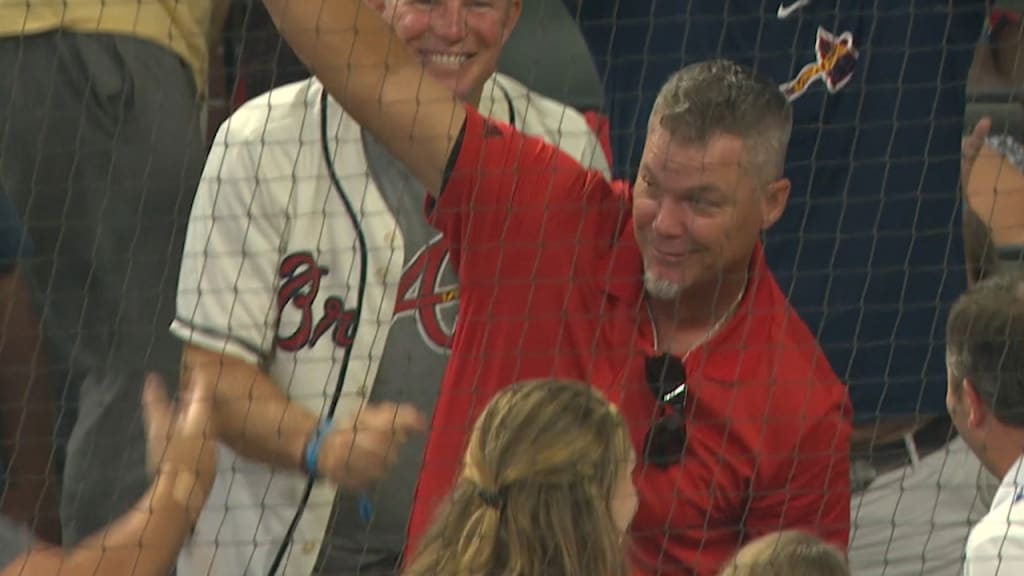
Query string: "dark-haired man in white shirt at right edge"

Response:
xmin=946 ymin=269 xmax=1024 ymax=576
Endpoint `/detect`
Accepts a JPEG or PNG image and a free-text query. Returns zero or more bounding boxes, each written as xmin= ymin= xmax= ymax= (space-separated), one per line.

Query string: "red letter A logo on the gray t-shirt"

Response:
xmin=394 ymin=235 xmax=459 ymax=353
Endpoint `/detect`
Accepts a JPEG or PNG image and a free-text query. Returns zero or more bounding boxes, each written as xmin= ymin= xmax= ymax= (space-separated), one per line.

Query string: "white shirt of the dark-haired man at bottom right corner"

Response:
xmin=964 ymin=457 xmax=1024 ymax=576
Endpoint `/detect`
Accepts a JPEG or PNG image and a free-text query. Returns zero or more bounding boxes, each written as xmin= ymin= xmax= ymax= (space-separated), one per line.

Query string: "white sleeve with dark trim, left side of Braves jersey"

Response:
xmin=171 ymin=117 xmax=288 ymax=364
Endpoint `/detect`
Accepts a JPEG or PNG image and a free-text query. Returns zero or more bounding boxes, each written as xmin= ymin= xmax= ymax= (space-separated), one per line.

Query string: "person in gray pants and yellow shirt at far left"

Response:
xmin=0 ymin=0 xmax=228 ymax=545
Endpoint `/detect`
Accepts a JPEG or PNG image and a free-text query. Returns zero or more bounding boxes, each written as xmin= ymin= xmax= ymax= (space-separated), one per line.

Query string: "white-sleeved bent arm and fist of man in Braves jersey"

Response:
xmin=171 ymin=106 xmax=425 ymax=488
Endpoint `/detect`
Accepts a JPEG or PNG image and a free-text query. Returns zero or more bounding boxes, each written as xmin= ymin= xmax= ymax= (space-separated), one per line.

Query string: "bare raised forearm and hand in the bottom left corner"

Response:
xmin=0 ymin=373 xmax=216 ymax=576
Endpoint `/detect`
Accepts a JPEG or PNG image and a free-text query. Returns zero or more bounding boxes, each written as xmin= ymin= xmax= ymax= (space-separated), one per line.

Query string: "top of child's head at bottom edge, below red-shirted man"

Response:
xmin=720 ymin=530 xmax=850 ymax=576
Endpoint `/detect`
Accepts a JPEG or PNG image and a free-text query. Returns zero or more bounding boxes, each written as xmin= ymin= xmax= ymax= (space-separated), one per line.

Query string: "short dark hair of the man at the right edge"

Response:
xmin=946 ymin=271 xmax=1024 ymax=427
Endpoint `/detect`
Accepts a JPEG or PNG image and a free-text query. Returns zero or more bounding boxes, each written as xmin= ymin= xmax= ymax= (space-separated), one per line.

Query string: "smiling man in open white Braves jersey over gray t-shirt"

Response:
xmin=171 ymin=0 xmax=608 ymax=576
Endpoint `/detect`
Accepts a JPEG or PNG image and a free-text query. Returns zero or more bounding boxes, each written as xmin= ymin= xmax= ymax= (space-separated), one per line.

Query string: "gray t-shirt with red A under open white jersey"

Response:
xmin=316 ymin=132 xmax=459 ymax=576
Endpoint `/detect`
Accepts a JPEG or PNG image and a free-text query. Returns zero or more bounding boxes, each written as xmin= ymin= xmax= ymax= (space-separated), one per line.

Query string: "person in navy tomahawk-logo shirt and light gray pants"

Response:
xmin=564 ymin=0 xmax=1024 ymax=576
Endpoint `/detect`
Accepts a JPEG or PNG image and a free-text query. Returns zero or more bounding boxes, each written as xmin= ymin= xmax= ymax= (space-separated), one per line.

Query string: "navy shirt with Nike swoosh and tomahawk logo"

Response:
xmin=565 ymin=0 xmax=986 ymax=421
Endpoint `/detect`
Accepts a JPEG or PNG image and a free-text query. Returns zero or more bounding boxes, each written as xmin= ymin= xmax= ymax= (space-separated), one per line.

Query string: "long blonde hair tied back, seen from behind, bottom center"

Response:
xmin=406 ymin=379 xmax=633 ymax=576
